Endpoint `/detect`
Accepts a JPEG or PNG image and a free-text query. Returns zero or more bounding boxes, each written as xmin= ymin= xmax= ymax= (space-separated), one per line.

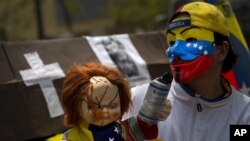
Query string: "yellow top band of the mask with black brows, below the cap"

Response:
xmin=167 ymin=26 xmax=214 ymax=46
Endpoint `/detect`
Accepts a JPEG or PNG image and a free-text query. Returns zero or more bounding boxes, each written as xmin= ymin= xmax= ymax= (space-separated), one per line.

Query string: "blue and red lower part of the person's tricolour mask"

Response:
xmin=167 ymin=40 xmax=214 ymax=83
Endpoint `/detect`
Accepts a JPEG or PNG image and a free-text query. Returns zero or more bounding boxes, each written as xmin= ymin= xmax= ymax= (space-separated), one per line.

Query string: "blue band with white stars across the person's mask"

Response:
xmin=166 ymin=40 xmax=215 ymax=63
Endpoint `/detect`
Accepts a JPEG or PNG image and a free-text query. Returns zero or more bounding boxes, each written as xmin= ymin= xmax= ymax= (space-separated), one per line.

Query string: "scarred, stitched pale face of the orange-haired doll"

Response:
xmin=82 ymin=76 xmax=121 ymax=126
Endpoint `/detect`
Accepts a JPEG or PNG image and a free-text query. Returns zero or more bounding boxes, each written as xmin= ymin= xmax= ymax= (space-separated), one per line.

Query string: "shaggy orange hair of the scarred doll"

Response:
xmin=61 ymin=63 xmax=132 ymax=127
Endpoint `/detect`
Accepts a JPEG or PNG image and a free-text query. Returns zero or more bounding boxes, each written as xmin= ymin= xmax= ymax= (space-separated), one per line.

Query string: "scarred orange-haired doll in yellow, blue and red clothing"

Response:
xmin=61 ymin=63 xmax=169 ymax=141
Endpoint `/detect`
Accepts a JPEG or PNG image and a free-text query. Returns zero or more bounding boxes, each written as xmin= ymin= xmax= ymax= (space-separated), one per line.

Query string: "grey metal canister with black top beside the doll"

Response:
xmin=139 ymin=73 xmax=173 ymax=123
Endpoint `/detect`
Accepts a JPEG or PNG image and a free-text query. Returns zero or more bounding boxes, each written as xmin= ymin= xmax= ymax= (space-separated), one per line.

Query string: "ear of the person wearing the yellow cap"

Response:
xmin=216 ymin=41 xmax=229 ymax=61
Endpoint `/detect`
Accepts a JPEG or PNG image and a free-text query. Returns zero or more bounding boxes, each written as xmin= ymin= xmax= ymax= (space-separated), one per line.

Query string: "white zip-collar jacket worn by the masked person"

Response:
xmin=123 ymin=81 xmax=250 ymax=141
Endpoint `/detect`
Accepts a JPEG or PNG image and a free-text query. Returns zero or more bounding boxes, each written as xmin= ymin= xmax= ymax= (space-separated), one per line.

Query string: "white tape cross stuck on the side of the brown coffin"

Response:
xmin=19 ymin=52 xmax=65 ymax=118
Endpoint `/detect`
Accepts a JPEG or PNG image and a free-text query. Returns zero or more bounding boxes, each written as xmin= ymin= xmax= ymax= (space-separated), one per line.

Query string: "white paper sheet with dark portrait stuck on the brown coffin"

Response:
xmin=86 ymin=34 xmax=150 ymax=86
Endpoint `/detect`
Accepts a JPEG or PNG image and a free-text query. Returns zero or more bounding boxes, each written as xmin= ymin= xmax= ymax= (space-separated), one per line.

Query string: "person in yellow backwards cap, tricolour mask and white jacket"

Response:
xmin=123 ymin=2 xmax=250 ymax=141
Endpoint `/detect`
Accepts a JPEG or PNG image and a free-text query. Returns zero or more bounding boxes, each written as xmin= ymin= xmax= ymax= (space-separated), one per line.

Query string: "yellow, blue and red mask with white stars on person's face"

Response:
xmin=166 ymin=26 xmax=215 ymax=83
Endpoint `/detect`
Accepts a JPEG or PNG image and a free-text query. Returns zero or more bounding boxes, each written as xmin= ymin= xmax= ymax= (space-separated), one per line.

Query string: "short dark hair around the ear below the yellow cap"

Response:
xmin=214 ymin=32 xmax=238 ymax=73
